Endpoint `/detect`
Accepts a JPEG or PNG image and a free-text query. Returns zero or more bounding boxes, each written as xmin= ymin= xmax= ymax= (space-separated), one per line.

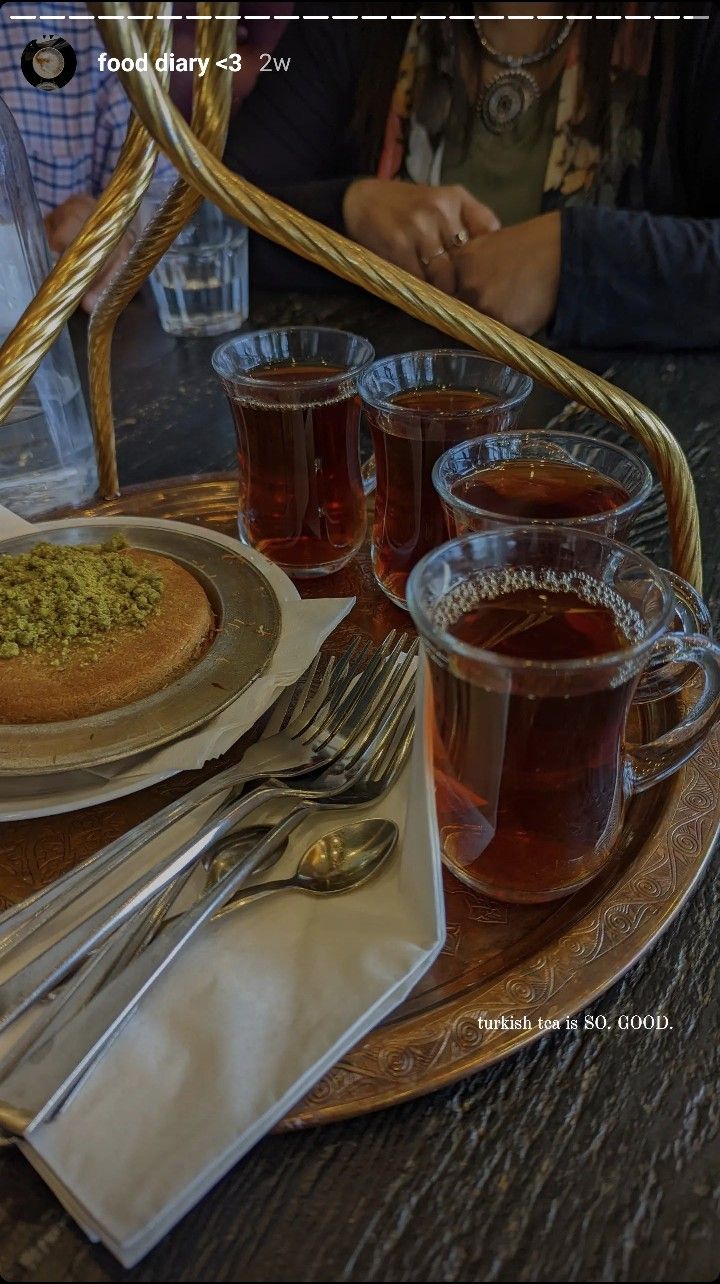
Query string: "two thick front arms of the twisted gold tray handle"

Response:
xmin=0 ymin=4 xmax=702 ymax=588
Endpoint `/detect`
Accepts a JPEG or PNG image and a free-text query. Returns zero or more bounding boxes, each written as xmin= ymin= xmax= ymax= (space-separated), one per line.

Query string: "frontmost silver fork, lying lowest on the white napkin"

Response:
xmin=0 ymin=686 xmax=413 ymax=1134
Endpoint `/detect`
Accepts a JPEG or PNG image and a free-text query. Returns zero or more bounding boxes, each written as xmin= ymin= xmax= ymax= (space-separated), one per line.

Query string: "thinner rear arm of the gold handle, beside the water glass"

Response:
xmin=87 ymin=4 xmax=236 ymax=498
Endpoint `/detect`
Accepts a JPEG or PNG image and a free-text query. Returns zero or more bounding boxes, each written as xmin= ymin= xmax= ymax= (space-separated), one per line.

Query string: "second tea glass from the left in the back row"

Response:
xmin=358 ymin=349 xmax=533 ymax=606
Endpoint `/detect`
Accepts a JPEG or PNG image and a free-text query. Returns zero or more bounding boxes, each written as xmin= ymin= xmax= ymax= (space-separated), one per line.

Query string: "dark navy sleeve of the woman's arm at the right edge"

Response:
xmin=551 ymin=13 xmax=720 ymax=349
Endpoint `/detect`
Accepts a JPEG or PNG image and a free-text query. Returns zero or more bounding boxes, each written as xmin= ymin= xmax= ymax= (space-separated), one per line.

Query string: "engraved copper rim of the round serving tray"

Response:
xmin=40 ymin=474 xmax=720 ymax=1131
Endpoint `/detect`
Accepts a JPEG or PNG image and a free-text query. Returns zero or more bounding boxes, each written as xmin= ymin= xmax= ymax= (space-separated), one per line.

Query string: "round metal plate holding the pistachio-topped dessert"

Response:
xmin=0 ymin=519 xmax=281 ymax=778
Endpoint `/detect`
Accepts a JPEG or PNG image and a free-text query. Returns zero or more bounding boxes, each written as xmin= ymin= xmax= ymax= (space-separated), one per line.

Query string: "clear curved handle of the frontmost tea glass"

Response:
xmin=625 ymin=633 xmax=720 ymax=794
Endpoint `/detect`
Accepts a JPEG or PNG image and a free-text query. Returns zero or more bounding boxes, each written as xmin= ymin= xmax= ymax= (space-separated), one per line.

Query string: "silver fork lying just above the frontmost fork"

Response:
xmin=0 ymin=654 xmax=415 ymax=1030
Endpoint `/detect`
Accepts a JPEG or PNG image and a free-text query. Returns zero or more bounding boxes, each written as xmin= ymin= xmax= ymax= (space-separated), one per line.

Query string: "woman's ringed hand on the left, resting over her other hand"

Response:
xmin=343 ymin=178 xmax=501 ymax=294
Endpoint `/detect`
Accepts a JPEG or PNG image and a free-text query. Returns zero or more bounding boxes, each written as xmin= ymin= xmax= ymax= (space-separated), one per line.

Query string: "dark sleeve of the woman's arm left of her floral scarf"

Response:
xmin=225 ymin=18 xmax=362 ymax=290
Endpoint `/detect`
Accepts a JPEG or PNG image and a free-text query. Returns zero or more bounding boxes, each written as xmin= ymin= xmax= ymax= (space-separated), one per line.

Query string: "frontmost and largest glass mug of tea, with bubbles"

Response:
xmin=408 ymin=524 xmax=720 ymax=903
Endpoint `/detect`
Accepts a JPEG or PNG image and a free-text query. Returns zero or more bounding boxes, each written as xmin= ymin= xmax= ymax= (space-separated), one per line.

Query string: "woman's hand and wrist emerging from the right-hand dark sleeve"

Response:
xmin=448 ymin=211 xmax=560 ymax=334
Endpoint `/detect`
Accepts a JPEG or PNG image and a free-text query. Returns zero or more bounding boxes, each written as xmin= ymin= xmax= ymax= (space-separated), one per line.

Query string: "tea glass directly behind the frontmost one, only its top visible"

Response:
xmin=433 ymin=429 xmax=652 ymax=539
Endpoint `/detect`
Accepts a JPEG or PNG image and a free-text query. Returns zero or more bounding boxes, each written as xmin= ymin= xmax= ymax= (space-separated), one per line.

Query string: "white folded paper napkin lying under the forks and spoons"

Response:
xmin=0 ymin=675 xmax=445 ymax=1267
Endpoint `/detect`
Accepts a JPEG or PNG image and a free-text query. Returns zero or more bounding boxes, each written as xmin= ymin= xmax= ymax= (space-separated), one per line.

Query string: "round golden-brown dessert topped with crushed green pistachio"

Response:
xmin=0 ymin=535 xmax=216 ymax=724
